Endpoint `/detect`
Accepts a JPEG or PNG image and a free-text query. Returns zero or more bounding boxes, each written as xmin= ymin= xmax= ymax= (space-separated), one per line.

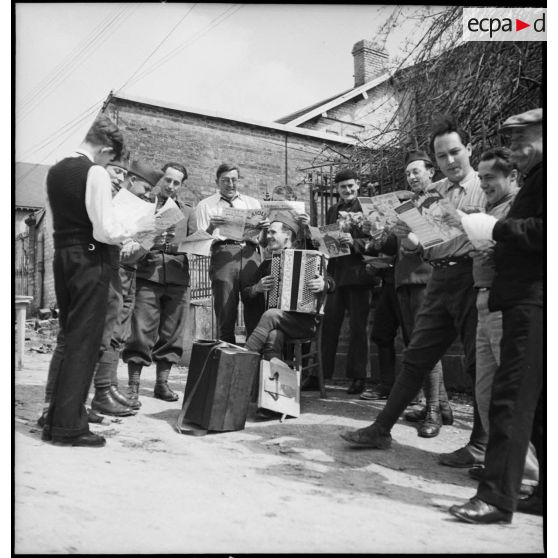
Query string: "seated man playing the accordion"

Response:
xmin=243 ymin=213 xmax=335 ymax=360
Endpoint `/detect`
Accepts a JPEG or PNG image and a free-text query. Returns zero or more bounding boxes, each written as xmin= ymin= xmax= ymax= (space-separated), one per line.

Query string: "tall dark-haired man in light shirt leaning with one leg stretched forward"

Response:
xmin=341 ymin=117 xmax=487 ymax=468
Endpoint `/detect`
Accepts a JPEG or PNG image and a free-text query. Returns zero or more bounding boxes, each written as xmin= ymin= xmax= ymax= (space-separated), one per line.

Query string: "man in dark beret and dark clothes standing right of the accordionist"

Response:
xmin=322 ymin=169 xmax=372 ymax=394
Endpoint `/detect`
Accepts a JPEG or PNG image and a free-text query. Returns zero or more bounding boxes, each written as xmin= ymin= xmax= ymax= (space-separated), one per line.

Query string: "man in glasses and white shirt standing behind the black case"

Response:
xmin=196 ymin=163 xmax=269 ymax=343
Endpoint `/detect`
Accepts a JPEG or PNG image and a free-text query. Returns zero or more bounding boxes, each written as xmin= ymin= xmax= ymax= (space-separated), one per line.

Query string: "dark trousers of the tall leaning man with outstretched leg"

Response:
xmin=376 ymin=262 xmax=490 ymax=457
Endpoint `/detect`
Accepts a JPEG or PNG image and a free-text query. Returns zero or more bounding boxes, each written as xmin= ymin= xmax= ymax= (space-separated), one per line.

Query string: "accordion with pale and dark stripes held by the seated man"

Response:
xmin=266 ymin=249 xmax=325 ymax=314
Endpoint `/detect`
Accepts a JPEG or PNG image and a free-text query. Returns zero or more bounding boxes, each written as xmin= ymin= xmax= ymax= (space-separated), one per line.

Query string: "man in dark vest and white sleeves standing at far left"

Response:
xmin=42 ymin=115 xmax=155 ymax=447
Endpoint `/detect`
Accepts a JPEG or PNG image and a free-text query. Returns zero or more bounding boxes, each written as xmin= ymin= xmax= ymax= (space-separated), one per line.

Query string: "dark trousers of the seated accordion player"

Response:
xmin=246 ymin=308 xmax=316 ymax=360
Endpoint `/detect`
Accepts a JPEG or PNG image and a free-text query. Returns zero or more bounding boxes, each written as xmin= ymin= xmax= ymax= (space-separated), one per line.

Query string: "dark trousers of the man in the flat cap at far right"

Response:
xmin=477 ymin=305 xmax=544 ymax=512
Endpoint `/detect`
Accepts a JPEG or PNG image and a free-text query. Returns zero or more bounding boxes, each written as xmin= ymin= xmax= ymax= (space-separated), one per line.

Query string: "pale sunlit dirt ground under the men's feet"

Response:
xmin=15 ymin=353 xmax=543 ymax=554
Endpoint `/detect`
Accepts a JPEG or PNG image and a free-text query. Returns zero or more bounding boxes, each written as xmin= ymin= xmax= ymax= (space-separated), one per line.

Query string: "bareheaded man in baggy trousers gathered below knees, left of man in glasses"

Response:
xmin=122 ymin=162 xmax=197 ymax=401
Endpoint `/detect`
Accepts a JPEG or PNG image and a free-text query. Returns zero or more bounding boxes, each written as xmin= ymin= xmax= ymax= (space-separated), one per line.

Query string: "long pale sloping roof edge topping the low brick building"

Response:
xmin=109 ymin=92 xmax=357 ymax=145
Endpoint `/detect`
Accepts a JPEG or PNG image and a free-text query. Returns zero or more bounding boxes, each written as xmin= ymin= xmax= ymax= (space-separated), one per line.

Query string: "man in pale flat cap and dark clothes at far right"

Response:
xmin=450 ymin=109 xmax=546 ymax=523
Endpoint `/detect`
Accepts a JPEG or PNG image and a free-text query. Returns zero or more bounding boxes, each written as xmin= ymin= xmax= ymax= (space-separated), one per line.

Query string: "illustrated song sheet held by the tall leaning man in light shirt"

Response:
xmin=395 ymin=190 xmax=464 ymax=248
